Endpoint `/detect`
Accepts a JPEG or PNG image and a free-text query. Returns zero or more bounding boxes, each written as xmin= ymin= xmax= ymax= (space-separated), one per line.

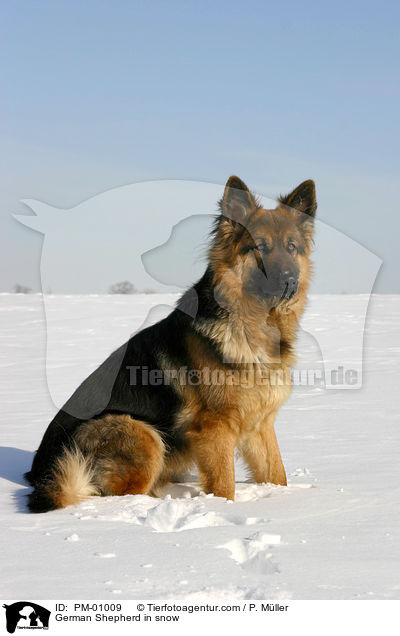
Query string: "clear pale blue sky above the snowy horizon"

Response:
xmin=0 ymin=0 xmax=400 ymax=293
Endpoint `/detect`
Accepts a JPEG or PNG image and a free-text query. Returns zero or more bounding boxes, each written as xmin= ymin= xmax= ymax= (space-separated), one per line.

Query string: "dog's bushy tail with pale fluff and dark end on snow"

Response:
xmin=28 ymin=447 xmax=100 ymax=512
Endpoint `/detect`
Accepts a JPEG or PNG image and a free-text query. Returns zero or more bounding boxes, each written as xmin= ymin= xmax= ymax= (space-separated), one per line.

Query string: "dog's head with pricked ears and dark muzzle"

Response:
xmin=210 ymin=176 xmax=317 ymax=306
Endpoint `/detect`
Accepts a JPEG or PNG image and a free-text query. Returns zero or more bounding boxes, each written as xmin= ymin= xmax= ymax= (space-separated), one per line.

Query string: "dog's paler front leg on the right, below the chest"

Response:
xmin=240 ymin=411 xmax=287 ymax=486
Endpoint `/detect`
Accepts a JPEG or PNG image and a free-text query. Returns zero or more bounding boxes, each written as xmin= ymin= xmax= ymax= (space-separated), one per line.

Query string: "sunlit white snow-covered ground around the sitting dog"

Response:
xmin=0 ymin=294 xmax=400 ymax=600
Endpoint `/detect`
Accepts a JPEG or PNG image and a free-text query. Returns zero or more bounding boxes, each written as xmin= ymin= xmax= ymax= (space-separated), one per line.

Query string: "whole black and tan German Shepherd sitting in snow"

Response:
xmin=25 ymin=176 xmax=317 ymax=512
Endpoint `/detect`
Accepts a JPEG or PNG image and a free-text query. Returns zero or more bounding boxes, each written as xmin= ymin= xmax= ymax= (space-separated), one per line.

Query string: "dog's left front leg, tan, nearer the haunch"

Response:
xmin=188 ymin=413 xmax=237 ymax=499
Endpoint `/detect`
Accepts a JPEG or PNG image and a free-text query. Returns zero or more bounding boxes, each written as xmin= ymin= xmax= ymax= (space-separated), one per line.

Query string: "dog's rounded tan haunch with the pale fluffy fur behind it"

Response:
xmin=39 ymin=414 xmax=165 ymax=508
